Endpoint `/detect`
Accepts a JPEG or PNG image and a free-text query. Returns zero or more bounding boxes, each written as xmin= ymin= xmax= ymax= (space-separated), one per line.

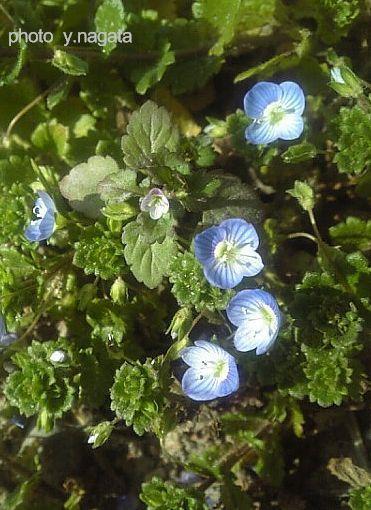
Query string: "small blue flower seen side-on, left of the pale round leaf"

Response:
xmin=24 ymin=191 xmax=57 ymax=241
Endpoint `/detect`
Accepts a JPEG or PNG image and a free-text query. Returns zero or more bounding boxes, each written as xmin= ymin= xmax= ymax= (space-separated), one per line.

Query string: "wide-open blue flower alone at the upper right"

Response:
xmin=244 ymin=81 xmax=305 ymax=145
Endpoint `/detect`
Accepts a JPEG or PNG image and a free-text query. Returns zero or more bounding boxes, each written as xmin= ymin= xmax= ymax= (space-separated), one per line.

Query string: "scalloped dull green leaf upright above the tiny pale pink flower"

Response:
xmin=122 ymin=101 xmax=179 ymax=170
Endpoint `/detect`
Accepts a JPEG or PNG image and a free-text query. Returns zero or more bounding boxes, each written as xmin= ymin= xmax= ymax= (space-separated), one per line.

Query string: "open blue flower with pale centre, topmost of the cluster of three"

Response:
xmin=195 ymin=218 xmax=264 ymax=289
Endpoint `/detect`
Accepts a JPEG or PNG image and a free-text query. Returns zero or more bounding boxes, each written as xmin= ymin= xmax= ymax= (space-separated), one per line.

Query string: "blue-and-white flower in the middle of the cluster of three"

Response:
xmin=226 ymin=289 xmax=282 ymax=354
